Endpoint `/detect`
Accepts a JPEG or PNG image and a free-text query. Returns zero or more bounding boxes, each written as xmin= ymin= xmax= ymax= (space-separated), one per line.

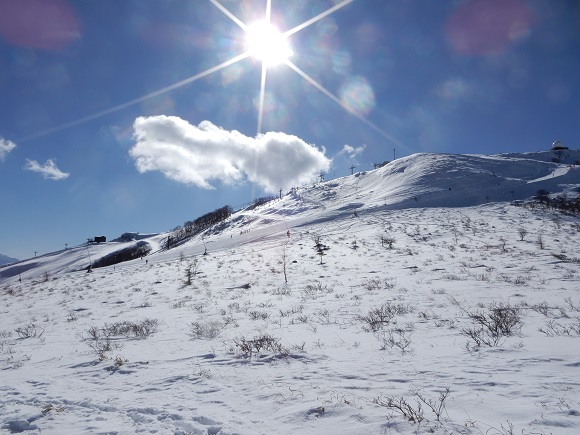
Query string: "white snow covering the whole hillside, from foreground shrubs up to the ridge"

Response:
xmin=0 ymin=150 xmax=580 ymax=434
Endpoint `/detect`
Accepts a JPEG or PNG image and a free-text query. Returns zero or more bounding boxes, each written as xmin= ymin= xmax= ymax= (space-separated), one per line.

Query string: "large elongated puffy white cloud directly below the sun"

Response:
xmin=129 ymin=115 xmax=330 ymax=192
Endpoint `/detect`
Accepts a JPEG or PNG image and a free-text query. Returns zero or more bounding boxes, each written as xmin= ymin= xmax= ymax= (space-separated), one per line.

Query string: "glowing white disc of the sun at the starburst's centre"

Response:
xmin=246 ymin=21 xmax=292 ymax=66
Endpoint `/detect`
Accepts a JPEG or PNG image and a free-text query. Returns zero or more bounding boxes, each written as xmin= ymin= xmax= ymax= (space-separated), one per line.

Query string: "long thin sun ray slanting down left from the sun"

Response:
xmin=18 ymin=51 xmax=251 ymax=142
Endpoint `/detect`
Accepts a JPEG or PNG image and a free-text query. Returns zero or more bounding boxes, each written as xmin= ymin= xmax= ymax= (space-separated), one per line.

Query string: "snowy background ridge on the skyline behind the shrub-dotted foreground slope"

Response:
xmin=0 ymin=150 xmax=580 ymax=282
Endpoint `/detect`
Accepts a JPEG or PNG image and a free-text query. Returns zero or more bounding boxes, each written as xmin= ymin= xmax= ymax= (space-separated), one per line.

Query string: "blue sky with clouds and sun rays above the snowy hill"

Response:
xmin=0 ymin=0 xmax=580 ymax=259
